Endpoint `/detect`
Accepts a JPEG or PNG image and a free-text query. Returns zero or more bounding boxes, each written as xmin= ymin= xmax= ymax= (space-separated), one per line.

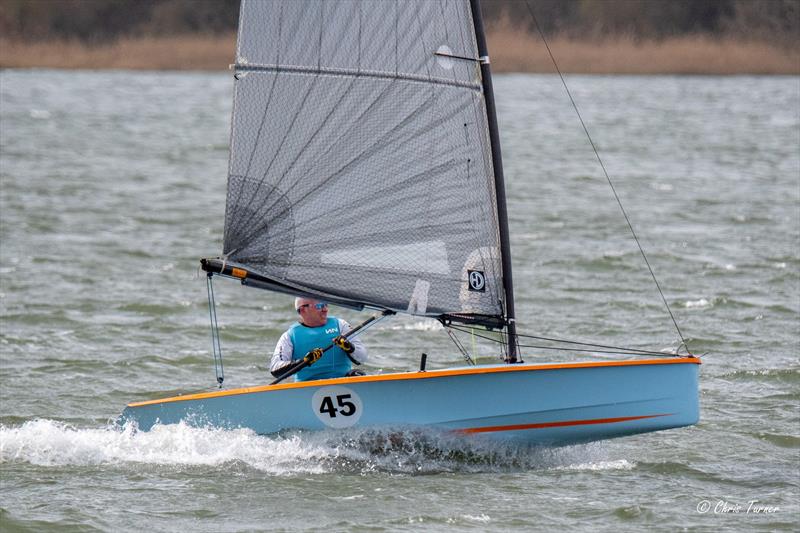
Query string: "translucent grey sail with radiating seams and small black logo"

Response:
xmin=223 ymin=0 xmax=503 ymax=317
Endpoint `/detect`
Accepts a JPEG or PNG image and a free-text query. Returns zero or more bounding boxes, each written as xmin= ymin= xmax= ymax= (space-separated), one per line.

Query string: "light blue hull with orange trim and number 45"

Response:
xmin=121 ymin=358 xmax=699 ymax=445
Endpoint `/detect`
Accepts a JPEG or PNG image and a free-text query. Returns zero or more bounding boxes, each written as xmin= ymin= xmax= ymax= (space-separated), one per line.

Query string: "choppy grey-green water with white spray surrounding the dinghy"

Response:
xmin=0 ymin=70 xmax=800 ymax=531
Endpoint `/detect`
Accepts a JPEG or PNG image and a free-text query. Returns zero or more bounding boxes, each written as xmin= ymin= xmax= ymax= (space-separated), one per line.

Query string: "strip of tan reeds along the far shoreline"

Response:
xmin=0 ymin=31 xmax=800 ymax=75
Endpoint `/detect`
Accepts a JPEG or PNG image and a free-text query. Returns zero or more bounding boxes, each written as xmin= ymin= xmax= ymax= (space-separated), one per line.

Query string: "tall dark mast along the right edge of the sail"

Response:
xmin=469 ymin=0 xmax=517 ymax=363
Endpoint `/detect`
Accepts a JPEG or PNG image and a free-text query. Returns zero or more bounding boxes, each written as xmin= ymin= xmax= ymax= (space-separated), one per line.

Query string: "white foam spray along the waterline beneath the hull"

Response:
xmin=0 ymin=419 xmax=634 ymax=476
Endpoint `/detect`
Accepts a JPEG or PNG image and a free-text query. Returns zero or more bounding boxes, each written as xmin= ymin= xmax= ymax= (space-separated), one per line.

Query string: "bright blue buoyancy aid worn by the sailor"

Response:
xmin=289 ymin=317 xmax=352 ymax=381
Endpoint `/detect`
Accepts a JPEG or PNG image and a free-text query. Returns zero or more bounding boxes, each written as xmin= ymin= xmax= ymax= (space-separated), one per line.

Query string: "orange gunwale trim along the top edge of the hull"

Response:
xmin=128 ymin=357 xmax=701 ymax=407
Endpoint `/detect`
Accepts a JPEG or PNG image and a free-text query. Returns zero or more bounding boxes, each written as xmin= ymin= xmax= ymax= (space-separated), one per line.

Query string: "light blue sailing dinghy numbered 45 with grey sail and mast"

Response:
xmin=121 ymin=0 xmax=700 ymax=445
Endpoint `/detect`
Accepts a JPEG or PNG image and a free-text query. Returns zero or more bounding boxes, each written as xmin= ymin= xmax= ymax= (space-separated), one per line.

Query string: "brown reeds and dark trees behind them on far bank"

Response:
xmin=0 ymin=0 xmax=800 ymax=74
